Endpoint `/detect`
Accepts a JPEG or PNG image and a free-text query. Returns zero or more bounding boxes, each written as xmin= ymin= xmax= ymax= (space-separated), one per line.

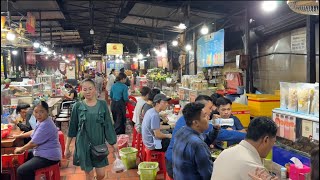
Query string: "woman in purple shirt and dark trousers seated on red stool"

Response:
xmin=14 ymin=101 xmax=61 ymax=180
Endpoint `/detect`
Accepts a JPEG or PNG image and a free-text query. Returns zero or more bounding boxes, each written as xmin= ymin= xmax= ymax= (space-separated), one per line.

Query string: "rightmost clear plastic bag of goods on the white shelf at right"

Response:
xmin=297 ymin=83 xmax=314 ymax=114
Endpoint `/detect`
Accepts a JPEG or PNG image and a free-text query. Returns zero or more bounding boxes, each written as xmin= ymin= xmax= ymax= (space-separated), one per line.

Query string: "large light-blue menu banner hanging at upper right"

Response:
xmin=197 ymin=29 xmax=224 ymax=67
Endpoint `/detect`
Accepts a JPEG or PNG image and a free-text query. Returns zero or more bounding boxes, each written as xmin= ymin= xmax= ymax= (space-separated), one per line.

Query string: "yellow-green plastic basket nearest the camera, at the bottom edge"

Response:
xmin=138 ymin=162 xmax=159 ymax=180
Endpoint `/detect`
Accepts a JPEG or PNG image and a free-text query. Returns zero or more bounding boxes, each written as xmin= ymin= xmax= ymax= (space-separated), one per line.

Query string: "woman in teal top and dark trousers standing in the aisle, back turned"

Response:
xmin=110 ymin=73 xmax=129 ymax=135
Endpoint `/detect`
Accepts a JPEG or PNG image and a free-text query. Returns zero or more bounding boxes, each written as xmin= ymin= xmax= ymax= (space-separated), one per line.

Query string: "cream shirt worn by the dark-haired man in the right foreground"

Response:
xmin=211 ymin=140 xmax=264 ymax=180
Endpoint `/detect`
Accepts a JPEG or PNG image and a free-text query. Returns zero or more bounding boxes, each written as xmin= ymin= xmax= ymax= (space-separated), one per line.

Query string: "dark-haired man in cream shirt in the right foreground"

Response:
xmin=211 ymin=117 xmax=277 ymax=180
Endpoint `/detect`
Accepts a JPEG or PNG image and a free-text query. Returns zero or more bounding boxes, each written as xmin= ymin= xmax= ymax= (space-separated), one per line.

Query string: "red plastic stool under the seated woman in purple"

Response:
xmin=35 ymin=164 xmax=60 ymax=180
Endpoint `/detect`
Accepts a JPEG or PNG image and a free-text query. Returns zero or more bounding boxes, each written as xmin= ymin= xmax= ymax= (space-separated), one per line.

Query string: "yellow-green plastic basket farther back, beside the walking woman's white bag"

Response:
xmin=119 ymin=147 xmax=138 ymax=169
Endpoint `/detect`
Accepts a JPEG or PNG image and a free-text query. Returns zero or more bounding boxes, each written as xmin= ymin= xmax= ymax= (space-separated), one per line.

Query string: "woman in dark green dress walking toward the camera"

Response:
xmin=65 ymin=79 xmax=119 ymax=180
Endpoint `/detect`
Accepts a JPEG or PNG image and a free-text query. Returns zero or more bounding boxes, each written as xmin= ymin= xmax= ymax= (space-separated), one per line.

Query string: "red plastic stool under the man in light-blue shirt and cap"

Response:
xmin=144 ymin=147 xmax=167 ymax=175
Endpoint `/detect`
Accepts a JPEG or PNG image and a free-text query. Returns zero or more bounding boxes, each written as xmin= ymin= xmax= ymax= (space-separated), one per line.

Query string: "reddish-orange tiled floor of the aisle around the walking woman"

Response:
xmin=60 ymin=93 xmax=164 ymax=180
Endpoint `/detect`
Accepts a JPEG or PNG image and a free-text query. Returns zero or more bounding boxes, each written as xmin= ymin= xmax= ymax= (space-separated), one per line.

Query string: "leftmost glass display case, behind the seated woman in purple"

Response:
xmin=9 ymin=84 xmax=43 ymax=105
